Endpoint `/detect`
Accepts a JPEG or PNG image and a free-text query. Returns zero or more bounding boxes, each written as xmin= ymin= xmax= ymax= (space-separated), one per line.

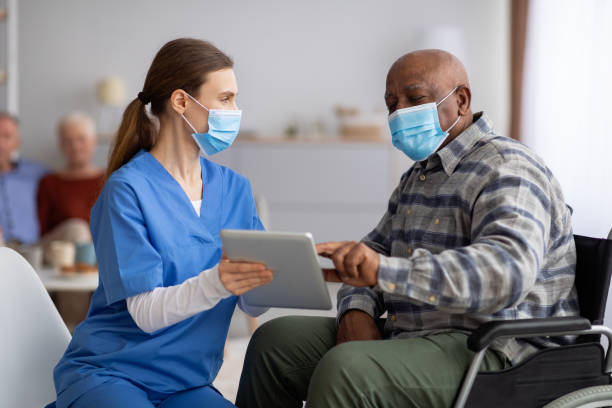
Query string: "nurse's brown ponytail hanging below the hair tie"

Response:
xmin=105 ymin=98 xmax=154 ymax=180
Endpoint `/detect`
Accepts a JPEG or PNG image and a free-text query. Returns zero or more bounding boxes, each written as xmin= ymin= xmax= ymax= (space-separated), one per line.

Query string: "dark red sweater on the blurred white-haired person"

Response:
xmin=37 ymin=173 xmax=104 ymax=236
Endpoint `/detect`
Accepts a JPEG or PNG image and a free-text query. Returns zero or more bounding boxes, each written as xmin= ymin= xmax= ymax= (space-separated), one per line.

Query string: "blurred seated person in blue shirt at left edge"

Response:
xmin=0 ymin=112 xmax=46 ymax=245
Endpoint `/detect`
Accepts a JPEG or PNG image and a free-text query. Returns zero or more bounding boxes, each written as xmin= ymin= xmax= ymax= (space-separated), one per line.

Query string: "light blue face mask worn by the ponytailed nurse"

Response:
xmin=181 ymin=94 xmax=242 ymax=156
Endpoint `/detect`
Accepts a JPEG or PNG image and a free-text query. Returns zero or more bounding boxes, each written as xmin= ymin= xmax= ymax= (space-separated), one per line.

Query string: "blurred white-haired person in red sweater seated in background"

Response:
xmin=38 ymin=112 xmax=104 ymax=329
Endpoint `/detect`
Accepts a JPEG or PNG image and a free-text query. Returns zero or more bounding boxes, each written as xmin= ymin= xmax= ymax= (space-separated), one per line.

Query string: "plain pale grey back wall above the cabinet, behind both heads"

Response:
xmin=19 ymin=0 xmax=509 ymax=165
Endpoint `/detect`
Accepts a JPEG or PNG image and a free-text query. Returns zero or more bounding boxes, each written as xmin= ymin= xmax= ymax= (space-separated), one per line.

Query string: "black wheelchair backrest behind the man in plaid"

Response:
xmin=574 ymin=235 xmax=612 ymax=324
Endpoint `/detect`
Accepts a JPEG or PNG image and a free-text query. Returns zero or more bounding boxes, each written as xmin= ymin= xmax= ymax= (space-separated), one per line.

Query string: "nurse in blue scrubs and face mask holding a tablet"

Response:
xmin=49 ymin=39 xmax=273 ymax=408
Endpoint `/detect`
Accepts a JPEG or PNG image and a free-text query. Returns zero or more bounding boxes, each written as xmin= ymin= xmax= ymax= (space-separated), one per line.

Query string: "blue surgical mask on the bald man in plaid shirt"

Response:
xmin=389 ymin=87 xmax=461 ymax=161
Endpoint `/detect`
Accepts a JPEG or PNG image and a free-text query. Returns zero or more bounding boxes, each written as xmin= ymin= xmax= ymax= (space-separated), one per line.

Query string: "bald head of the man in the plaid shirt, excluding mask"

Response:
xmin=385 ymin=50 xmax=473 ymax=148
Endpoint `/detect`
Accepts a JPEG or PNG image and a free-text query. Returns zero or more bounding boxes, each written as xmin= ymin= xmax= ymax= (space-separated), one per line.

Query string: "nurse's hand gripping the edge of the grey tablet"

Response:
xmin=219 ymin=257 xmax=274 ymax=296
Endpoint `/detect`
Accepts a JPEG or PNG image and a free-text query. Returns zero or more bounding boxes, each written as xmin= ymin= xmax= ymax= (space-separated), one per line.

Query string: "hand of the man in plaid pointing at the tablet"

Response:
xmin=316 ymin=241 xmax=379 ymax=287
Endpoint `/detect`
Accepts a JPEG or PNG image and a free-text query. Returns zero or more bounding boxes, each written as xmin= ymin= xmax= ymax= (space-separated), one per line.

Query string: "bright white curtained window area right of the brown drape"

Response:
xmin=522 ymin=0 xmax=612 ymax=237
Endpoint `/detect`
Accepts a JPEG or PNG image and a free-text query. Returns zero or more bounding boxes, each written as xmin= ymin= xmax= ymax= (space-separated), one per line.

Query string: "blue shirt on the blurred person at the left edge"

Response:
xmin=0 ymin=160 xmax=47 ymax=245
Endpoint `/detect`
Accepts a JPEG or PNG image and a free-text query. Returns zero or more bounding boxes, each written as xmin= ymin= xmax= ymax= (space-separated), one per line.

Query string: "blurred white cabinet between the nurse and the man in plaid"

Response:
xmin=213 ymin=141 xmax=409 ymax=242
